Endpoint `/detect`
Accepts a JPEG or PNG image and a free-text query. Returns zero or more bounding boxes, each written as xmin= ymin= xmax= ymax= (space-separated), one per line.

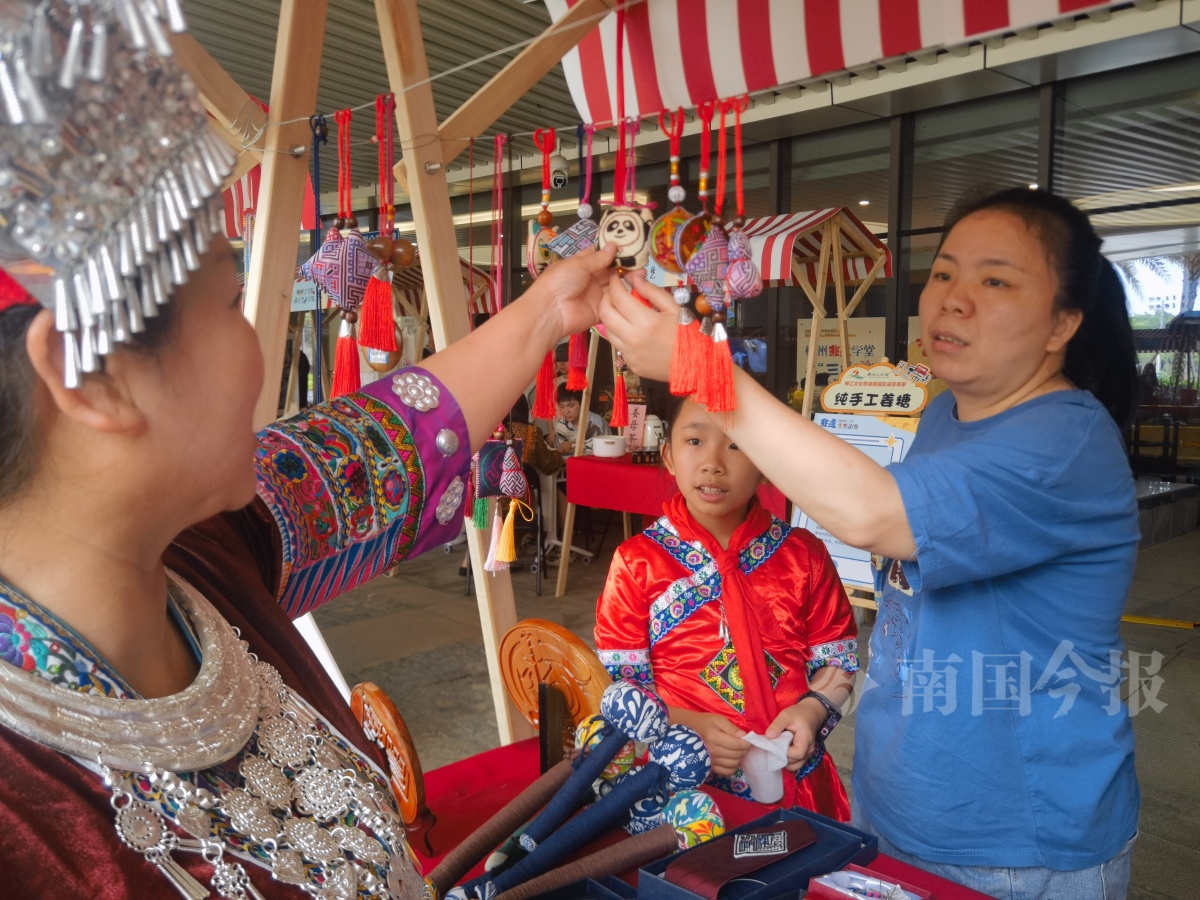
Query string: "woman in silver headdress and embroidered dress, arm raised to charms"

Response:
xmin=0 ymin=0 xmax=611 ymax=900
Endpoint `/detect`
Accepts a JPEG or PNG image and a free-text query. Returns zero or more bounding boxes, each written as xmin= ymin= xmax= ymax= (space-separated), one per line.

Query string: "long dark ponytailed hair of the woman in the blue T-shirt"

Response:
xmin=942 ymin=187 xmax=1138 ymax=430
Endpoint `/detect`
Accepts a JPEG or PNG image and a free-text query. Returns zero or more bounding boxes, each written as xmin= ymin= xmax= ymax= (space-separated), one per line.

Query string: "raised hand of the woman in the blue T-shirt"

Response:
xmin=600 ymin=270 xmax=679 ymax=382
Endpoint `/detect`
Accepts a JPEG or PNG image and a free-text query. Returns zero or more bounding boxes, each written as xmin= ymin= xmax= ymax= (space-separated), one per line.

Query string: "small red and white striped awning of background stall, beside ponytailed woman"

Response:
xmin=743 ymin=206 xmax=892 ymax=284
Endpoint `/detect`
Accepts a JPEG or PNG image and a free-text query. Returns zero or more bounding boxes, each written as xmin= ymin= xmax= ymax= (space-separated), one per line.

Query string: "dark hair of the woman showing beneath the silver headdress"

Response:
xmin=0 ymin=297 xmax=174 ymax=506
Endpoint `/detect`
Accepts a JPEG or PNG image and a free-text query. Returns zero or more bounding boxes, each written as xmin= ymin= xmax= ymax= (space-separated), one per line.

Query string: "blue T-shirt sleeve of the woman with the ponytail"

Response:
xmin=888 ymin=391 xmax=1130 ymax=590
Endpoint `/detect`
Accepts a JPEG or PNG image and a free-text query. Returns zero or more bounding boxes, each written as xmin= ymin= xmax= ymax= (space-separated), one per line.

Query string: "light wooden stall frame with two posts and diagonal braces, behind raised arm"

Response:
xmin=172 ymin=0 xmax=617 ymax=743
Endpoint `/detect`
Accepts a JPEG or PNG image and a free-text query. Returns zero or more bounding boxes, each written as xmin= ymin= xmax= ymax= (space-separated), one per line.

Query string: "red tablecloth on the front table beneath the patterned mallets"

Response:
xmin=413 ymin=738 xmax=986 ymax=900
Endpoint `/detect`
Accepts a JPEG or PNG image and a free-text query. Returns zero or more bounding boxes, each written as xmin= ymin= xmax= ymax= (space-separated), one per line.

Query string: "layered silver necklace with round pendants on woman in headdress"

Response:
xmin=0 ymin=575 xmax=425 ymax=900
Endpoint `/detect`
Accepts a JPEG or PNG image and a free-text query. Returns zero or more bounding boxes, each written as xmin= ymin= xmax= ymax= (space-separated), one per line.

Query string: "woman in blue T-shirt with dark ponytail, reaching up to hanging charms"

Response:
xmin=602 ymin=188 xmax=1139 ymax=900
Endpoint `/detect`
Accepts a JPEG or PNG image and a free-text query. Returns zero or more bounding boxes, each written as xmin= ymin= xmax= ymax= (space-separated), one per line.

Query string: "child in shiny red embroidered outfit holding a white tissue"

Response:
xmin=595 ymin=400 xmax=858 ymax=822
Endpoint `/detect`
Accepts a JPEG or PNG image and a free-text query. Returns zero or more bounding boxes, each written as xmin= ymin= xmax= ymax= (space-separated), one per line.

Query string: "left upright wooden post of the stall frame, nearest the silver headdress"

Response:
xmin=246 ymin=0 xmax=328 ymax=428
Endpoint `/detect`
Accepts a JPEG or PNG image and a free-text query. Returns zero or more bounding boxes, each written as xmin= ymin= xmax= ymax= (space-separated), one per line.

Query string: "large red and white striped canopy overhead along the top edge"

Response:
xmin=546 ymin=0 xmax=1120 ymax=125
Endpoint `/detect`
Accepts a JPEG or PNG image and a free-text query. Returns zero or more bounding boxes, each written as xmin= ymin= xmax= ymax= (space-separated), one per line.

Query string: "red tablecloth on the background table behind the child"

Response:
xmin=566 ymin=455 xmax=787 ymax=520
